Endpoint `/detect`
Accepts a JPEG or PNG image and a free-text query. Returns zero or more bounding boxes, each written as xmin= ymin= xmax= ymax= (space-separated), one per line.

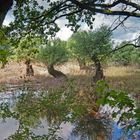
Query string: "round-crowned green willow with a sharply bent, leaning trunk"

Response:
xmin=37 ymin=39 xmax=68 ymax=78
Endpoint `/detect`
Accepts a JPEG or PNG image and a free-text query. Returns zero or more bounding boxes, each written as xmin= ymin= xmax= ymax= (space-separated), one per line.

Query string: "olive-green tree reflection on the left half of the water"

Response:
xmin=5 ymin=91 xmax=65 ymax=140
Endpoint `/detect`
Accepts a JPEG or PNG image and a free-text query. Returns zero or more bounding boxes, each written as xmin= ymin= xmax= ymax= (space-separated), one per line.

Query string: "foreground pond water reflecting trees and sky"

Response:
xmin=0 ymin=88 xmax=140 ymax=140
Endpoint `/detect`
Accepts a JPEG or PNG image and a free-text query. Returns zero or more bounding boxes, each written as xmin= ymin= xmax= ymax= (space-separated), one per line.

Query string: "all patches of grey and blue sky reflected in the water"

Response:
xmin=0 ymin=91 xmax=140 ymax=140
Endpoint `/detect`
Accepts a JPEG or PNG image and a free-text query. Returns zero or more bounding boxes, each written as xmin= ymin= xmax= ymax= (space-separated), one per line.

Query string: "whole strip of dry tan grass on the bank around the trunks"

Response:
xmin=0 ymin=62 xmax=140 ymax=98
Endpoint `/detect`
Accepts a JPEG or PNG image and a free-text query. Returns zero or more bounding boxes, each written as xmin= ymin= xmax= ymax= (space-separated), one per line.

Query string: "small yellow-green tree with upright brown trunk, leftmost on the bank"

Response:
xmin=15 ymin=35 xmax=40 ymax=76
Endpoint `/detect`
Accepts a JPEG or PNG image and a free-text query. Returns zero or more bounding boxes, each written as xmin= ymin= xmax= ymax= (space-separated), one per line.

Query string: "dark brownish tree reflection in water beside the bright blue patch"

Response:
xmin=72 ymin=116 xmax=112 ymax=140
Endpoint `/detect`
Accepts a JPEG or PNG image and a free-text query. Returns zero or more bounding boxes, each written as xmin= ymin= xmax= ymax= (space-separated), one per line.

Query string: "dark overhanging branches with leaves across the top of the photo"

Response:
xmin=1 ymin=0 xmax=140 ymax=39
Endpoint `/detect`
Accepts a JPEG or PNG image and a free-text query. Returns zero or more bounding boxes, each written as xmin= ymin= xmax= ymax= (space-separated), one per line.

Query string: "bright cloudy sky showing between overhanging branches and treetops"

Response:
xmin=4 ymin=11 xmax=140 ymax=42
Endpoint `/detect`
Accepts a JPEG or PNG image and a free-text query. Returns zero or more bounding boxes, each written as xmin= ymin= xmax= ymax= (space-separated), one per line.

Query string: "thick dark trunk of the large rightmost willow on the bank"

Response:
xmin=92 ymin=56 xmax=105 ymax=82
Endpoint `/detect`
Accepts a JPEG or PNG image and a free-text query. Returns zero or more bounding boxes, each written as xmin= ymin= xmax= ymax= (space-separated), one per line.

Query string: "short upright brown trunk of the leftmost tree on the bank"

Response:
xmin=25 ymin=60 xmax=34 ymax=76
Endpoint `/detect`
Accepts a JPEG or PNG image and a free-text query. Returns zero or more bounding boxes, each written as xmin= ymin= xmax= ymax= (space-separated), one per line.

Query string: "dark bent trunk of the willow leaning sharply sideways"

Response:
xmin=48 ymin=64 xmax=67 ymax=78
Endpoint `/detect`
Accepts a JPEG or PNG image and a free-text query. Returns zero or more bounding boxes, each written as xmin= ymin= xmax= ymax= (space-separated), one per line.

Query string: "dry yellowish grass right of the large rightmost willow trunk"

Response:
xmin=105 ymin=67 xmax=140 ymax=93
